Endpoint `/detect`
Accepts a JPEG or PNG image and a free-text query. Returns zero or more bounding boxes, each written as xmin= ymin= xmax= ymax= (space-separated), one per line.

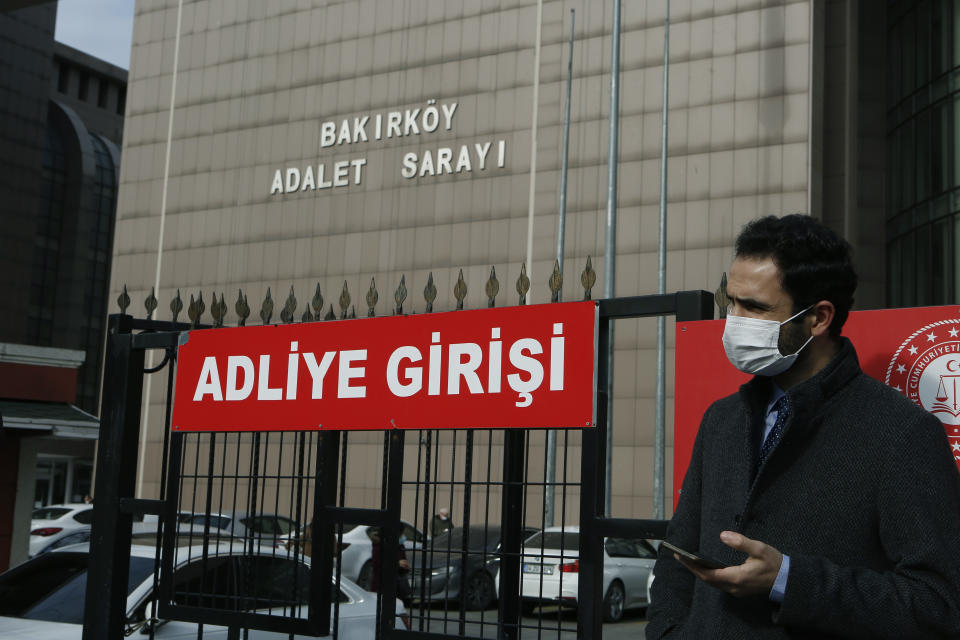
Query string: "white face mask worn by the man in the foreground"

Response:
xmin=723 ymin=305 xmax=813 ymax=376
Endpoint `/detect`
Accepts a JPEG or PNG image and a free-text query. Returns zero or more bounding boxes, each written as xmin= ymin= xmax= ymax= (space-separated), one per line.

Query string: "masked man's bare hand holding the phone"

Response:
xmin=673 ymin=531 xmax=783 ymax=597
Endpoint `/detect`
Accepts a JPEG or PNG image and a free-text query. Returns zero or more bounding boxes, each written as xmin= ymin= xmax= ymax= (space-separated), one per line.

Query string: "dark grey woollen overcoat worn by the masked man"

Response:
xmin=647 ymin=338 xmax=960 ymax=639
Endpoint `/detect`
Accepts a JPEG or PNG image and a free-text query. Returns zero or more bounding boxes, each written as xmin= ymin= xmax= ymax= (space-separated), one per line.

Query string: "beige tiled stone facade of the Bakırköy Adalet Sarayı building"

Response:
xmin=111 ymin=0 xmax=811 ymax=519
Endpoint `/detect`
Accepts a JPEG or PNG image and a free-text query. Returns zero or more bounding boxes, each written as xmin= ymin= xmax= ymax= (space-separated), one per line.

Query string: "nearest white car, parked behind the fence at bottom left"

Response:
xmin=0 ymin=544 xmax=407 ymax=640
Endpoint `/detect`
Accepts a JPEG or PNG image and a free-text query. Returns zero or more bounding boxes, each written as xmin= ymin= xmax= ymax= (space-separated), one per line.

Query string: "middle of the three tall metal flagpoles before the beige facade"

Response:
xmin=603 ymin=0 xmax=620 ymax=515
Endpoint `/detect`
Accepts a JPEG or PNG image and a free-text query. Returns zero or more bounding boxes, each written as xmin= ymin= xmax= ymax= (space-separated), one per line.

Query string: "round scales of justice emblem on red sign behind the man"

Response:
xmin=884 ymin=319 xmax=960 ymax=466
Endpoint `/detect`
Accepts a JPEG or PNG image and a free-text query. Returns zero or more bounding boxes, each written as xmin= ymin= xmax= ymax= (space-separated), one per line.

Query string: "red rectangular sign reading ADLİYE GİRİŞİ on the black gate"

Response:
xmin=172 ymin=302 xmax=597 ymax=431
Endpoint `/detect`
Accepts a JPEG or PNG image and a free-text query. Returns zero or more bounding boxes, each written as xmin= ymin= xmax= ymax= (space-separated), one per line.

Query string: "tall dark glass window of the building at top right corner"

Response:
xmin=886 ymin=0 xmax=960 ymax=307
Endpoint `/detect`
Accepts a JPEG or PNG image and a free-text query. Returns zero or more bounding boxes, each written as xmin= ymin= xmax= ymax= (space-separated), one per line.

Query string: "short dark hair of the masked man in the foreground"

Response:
xmin=736 ymin=213 xmax=857 ymax=337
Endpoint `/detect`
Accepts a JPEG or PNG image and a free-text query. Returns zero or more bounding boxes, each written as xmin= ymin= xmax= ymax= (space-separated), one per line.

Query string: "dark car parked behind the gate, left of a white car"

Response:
xmin=408 ymin=525 xmax=538 ymax=610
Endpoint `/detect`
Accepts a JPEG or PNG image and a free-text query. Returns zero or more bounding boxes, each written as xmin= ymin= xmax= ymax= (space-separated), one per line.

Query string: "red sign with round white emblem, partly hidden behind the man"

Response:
xmin=673 ymin=307 xmax=960 ymax=506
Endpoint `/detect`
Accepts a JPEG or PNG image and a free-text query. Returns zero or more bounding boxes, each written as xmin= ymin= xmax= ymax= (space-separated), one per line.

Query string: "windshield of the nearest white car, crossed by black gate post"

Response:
xmin=0 ymin=553 xmax=154 ymax=624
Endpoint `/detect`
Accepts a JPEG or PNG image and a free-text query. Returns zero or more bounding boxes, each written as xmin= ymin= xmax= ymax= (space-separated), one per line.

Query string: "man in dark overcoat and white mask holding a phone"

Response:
xmin=646 ymin=215 xmax=960 ymax=638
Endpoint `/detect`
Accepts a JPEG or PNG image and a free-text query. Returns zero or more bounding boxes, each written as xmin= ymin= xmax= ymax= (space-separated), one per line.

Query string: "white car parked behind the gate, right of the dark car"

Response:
xmin=520 ymin=527 xmax=657 ymax=622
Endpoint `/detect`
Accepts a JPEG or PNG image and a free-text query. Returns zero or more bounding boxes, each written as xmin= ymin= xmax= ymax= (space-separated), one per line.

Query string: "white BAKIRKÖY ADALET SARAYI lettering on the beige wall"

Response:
xmin=270 ymin=100 xmax=507 ymax=195
